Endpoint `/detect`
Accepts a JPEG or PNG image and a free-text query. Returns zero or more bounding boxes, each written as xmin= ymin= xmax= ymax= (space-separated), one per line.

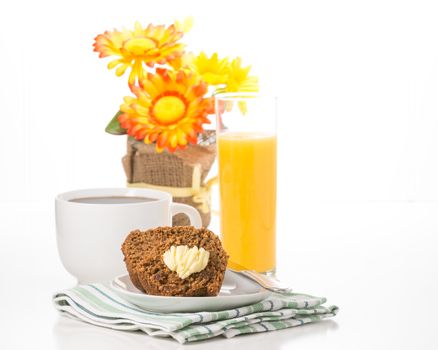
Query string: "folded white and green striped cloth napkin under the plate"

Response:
xmin=53 ymin=284 xmax=338 ymax=344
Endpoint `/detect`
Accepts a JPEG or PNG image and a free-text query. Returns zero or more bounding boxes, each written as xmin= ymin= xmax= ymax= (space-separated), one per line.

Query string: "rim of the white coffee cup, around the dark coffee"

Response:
xmin=55 ymin=187 xmax=172 ymax=207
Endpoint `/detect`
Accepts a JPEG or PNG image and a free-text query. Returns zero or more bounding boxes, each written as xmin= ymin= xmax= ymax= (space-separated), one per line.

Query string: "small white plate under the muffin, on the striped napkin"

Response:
xmin=111 ymin=270 xmax=270 ymax=313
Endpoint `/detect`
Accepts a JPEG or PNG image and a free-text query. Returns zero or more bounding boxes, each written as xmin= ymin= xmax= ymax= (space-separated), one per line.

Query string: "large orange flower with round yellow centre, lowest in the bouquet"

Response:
xmin=118 ymin=68 xmax=212 ymax=152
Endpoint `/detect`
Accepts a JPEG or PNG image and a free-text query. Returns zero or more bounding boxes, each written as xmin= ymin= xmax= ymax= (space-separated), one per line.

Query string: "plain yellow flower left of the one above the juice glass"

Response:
xmin=191 ymin=52 xmax=230 ymax=85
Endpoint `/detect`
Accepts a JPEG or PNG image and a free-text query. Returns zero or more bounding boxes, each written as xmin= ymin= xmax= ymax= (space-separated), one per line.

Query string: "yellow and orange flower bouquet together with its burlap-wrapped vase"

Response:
xmin=93 ymin=19 xmax=258 ymax=226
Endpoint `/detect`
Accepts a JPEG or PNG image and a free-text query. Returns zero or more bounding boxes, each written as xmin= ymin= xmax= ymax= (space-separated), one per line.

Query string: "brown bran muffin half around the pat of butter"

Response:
xmin=122 ymin=226 xmax=228 ymax=296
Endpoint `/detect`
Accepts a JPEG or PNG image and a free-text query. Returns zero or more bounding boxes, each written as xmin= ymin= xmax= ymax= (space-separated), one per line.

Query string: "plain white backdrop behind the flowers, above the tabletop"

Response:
xmin=0 ymin=0 xmax=438 ymax=201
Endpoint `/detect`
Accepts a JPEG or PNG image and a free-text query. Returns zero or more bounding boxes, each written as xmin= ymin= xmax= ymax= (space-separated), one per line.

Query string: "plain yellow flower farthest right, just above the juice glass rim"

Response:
xmin=224 ymin=57 xmax=259 ymax=92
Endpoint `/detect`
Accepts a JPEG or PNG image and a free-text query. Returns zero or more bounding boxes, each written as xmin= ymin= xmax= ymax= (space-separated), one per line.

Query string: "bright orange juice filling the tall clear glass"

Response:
xmin=218 ymin=132 xmax=277 ymax=272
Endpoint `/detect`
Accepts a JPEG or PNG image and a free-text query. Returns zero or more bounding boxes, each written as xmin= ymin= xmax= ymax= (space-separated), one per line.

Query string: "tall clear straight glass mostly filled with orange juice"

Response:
xmin=216 ymin=93 xmax=277 ymax=273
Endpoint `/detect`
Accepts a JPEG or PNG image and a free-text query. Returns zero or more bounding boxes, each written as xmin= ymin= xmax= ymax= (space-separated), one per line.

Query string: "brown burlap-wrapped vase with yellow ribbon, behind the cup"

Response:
xmin=122 ymin=132 xmax=216 ymax=227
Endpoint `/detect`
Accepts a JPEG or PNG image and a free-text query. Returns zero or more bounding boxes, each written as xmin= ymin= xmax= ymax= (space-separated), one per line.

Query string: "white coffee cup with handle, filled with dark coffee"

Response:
xmin=55 ymin=188 xmax=202 ymax=283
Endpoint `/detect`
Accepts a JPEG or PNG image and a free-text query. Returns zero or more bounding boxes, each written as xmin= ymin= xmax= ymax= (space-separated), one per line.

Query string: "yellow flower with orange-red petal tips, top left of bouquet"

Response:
xmin=93 ymin=22 xmax=184 ymax=86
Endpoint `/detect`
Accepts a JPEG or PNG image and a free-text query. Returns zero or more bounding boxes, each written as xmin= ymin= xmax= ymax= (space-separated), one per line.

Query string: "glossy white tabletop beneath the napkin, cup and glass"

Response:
xmin=0 ymin=201 xmax=438 ymax=350
